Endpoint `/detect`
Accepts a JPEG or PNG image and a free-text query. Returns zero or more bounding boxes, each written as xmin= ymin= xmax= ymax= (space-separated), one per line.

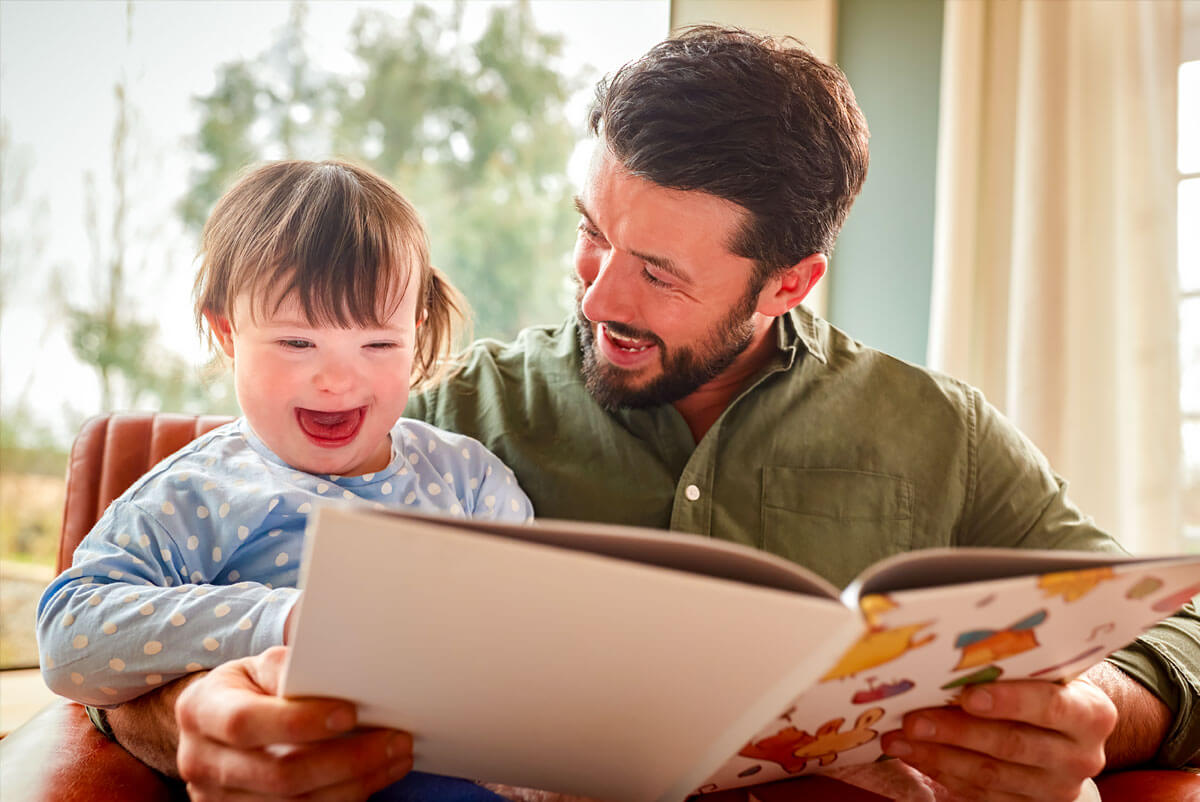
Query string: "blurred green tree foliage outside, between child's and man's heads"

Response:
xmin=181 ymin=4 xmax=582 ymax=337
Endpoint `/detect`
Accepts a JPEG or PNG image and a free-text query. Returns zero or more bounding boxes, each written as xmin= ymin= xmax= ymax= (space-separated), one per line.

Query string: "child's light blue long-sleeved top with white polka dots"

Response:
xmin=37 ymin=418 xmax=533 ymax=707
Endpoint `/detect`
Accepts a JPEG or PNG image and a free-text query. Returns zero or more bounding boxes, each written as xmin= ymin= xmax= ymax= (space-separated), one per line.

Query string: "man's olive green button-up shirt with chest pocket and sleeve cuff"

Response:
xmin=406 ymin=307 xmax=1200 ymax=765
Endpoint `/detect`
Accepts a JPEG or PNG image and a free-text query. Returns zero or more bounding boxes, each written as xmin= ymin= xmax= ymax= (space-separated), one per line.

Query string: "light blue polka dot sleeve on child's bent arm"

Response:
xmin=37 ymin=499 xmax=299 ymax=707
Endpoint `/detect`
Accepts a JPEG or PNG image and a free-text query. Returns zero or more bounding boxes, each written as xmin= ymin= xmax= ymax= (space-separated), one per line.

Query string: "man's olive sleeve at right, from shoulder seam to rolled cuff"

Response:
xmin=958 ymin=390 xmax=1200 ymax=766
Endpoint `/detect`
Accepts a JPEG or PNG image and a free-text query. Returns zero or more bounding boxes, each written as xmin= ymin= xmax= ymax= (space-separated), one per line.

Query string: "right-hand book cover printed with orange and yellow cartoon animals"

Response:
xmin=702 ymin=550 xmax=1200 ymax=790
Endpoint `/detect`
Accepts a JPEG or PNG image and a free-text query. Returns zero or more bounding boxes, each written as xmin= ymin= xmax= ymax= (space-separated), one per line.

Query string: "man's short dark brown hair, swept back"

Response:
xmin=588 ymin=25 xmax=868 ymax=276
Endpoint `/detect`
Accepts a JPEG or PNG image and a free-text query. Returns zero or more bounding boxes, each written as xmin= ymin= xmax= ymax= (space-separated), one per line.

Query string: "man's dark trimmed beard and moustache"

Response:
xmin=575 ymin=281 xmax=761 ymax=411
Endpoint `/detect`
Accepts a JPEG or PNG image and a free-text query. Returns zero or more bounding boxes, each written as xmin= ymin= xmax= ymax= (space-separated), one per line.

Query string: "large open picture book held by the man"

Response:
xmin=276 ymin=507 xmax=1200 ymax=802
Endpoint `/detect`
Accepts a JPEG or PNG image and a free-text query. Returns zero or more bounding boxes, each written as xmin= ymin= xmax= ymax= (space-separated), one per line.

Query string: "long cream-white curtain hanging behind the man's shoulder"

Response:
xmin=929 ymin=0 xmax=1182 ymax=552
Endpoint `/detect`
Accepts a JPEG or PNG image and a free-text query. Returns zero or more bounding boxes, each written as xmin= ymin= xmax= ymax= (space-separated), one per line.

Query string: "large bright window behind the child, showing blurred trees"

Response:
xmin=0 ymin=0 xmax=670 ymax=672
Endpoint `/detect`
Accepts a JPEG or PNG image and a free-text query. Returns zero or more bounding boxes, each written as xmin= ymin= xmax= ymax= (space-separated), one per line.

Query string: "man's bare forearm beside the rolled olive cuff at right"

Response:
xmin=1084 ymin=663 xmax=1174 ymax=771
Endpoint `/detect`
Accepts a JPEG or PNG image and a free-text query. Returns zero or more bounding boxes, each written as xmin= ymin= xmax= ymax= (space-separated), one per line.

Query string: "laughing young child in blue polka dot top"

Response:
xmin=37 ymin=161 xmax=533 ymax=725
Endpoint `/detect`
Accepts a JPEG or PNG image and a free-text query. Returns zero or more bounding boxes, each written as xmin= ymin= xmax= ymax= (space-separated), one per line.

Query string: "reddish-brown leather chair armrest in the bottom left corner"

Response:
xmin=0 ymin=699 xmax=181 ymax=802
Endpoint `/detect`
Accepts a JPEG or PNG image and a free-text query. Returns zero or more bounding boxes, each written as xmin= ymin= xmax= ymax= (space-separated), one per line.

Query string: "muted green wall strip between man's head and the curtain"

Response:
xmin=828 ymin=0 xmax=942 ymax=363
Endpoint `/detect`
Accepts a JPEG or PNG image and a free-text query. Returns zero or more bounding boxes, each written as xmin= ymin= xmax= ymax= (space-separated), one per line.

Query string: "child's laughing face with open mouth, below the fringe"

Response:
xmin=208 ymin=282 xmax=416 ymax=475
